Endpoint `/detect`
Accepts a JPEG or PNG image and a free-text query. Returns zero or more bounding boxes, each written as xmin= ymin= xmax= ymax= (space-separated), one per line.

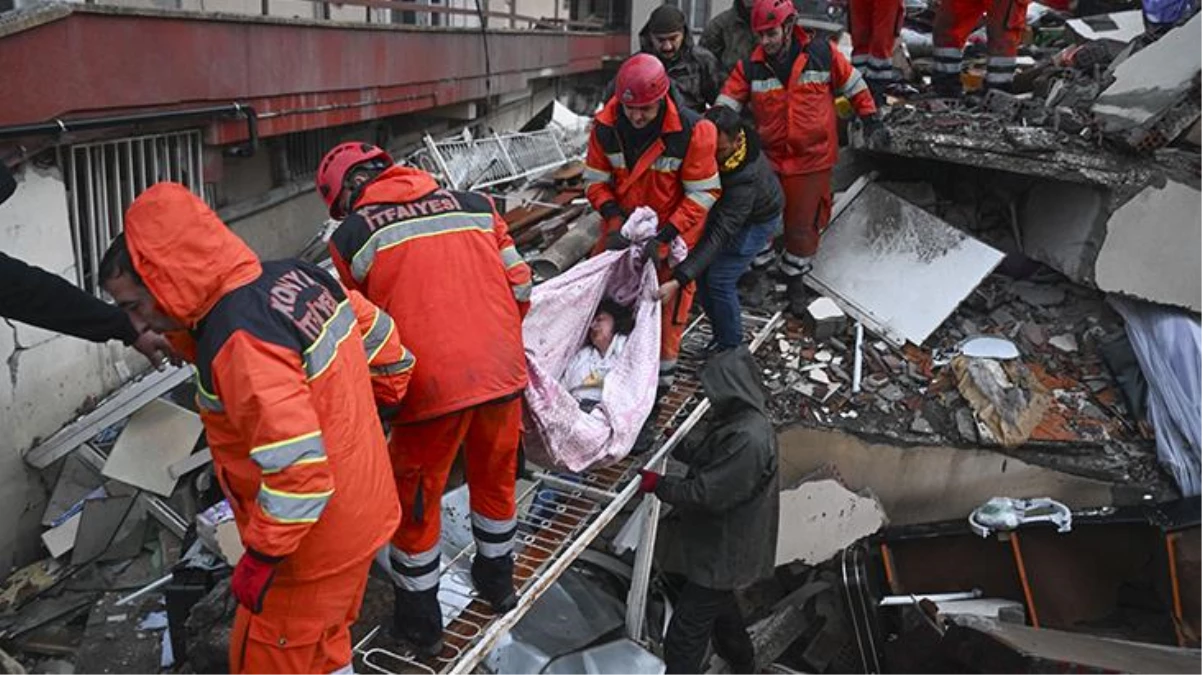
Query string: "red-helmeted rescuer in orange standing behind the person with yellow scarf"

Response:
xmin=718 ymin=0 xmax=887 ymax=315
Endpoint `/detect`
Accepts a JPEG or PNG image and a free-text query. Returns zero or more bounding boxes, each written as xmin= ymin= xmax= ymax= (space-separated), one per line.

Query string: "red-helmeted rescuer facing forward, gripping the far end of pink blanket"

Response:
xmin=584 ymin=54 xmax=722 ymax=396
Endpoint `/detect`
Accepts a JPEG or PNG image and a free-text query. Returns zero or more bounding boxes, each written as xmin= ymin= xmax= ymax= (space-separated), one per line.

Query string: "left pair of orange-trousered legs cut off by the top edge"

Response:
xmin=847 ymin=0 xmax=905 ymax=108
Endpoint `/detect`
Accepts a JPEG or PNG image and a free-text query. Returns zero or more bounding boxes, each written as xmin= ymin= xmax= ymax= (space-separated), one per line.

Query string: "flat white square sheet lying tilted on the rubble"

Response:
xmin=805 ymin=180 xmax=1002 ymax=346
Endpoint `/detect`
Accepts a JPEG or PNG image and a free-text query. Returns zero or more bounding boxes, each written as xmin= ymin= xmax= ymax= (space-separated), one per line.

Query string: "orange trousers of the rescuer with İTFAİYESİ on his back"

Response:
xmin=388 ymin=393 xmax=522 ymax=555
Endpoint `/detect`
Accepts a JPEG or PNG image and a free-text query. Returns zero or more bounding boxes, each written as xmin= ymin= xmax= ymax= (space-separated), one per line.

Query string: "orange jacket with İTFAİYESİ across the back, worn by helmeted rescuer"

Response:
xmin=329 ymin=167 xmax=531 ymax=424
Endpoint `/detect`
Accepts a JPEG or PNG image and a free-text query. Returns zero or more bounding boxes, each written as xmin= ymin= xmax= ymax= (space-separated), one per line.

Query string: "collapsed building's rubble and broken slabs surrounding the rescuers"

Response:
xmin=0 ymin=1 xmax=1202 ymax=674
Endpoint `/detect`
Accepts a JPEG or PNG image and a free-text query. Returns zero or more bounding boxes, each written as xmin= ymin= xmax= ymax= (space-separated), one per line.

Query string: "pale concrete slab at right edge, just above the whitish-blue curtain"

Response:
xmin=1095 ymin=180 xmax=1202 ymax=311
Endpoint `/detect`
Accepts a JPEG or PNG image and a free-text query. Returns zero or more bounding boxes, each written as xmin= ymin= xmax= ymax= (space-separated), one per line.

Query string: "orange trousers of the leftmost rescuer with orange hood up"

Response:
xmin=230 ymin=556 xmax=374 ymax=675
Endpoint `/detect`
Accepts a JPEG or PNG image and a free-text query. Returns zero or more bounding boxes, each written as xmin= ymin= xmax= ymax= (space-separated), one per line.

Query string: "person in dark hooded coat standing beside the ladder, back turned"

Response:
xmin=639 ymin=346 xmax=780 ymax=675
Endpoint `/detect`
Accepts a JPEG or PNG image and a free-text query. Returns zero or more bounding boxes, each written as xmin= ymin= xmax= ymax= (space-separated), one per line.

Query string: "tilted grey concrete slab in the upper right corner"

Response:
xmin=1093 ymin=14 xmax=1202 ymax=133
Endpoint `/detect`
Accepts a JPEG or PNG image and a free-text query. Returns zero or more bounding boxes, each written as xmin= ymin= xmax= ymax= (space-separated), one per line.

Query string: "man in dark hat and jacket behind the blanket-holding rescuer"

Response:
xmin=601 ymin=5 xmax=725 ymax=113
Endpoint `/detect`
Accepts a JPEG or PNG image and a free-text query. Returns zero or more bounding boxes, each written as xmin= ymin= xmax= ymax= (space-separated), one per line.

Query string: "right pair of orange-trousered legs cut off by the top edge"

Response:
xmin=932 ymin=0 xmax=1031 ymax=96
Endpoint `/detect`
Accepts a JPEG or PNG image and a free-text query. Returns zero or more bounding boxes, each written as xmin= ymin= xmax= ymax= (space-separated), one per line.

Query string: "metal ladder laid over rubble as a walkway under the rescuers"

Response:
xmin=355 ymin=311 xmax=784 ymax=675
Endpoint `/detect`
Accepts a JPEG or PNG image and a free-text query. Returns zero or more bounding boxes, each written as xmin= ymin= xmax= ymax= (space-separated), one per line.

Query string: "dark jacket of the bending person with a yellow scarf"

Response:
xmin=672 ymin=132 xmax=785 ymax=285
